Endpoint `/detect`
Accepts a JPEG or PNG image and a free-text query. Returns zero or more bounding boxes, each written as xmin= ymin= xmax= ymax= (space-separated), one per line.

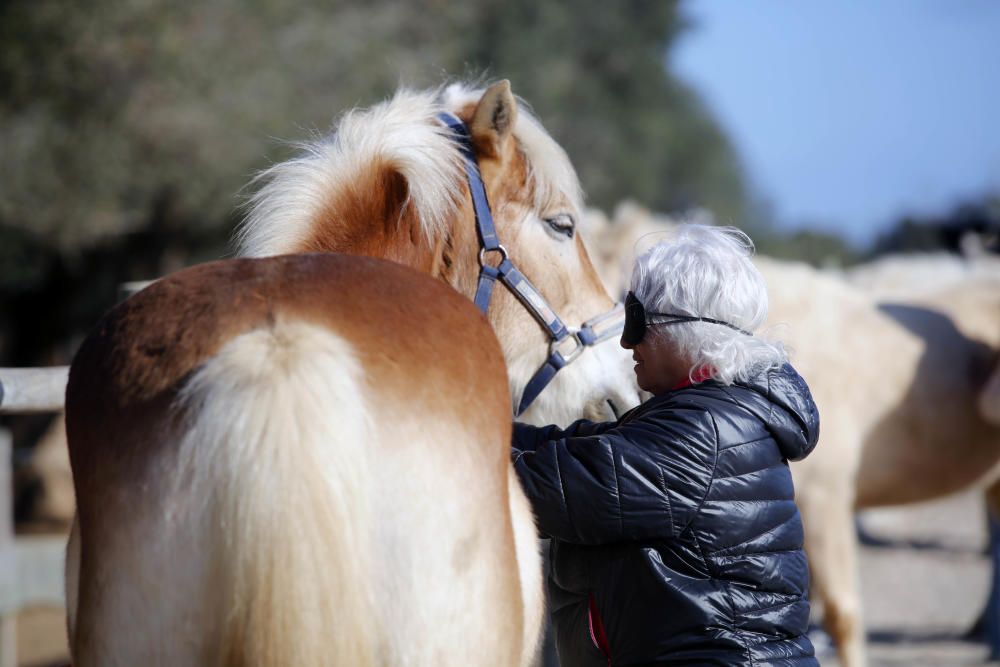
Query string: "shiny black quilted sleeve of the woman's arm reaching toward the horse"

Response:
xmin=514 ymin=408 xmax=717 ymax=544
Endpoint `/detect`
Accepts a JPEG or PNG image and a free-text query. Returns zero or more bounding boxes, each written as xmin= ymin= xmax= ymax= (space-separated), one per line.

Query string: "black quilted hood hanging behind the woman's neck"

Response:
xmin=738 ymin=364 xmax=819 ymax=461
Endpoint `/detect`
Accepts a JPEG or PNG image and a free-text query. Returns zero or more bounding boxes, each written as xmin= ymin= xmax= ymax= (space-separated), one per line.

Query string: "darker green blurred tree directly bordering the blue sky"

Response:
xmin=450 ymin=0 xmax=746 ymax=222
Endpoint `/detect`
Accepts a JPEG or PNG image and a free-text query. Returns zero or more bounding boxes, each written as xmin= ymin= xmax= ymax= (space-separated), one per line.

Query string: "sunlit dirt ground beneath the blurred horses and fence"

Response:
xmin=18 ymin=493 xmax=990 ymax=667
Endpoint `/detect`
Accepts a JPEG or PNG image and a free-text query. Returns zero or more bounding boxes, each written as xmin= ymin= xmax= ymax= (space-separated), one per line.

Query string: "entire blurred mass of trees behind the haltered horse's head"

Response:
xmin=0 ymin=0 xmax=744 ymax=248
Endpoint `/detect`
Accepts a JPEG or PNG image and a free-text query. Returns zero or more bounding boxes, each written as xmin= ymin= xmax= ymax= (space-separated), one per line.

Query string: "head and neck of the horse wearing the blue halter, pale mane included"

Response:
xmin=240 ymin=81 xmax=639 ymax=423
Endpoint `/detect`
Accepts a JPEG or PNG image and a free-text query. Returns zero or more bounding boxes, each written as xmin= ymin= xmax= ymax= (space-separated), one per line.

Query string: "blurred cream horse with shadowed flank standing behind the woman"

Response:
xmin=591 ymin=205 xmax=1000 ymax=667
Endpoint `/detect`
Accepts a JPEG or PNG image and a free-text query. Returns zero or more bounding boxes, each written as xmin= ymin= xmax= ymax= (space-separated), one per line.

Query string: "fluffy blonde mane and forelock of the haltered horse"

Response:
xmin=236 ymin=84 xmax=582 ymax=257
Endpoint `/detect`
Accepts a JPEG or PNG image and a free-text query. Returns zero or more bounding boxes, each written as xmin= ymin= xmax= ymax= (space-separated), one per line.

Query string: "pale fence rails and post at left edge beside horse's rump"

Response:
xmin=0 ymin=366 xmax=69 ymax=667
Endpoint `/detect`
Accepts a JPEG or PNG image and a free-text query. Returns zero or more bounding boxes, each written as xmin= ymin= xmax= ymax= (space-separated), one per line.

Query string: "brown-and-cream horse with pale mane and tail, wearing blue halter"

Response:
xmin=66 ymin=82 xmax=638 ymax=667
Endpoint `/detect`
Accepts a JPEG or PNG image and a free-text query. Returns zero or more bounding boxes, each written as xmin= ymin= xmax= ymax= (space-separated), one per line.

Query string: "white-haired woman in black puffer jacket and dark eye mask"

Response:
xmin=512 ymin=225 xmax=819 ymax=667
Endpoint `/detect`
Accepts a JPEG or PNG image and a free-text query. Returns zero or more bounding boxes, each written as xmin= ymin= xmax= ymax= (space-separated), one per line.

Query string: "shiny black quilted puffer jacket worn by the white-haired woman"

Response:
xmin=513 ymin=365 xmax=819 ymax=667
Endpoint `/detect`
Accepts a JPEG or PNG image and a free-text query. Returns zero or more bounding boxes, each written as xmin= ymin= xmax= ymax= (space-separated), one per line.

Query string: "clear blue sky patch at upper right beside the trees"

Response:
xmin=670 ymin=0 xmax=1000 ymax=243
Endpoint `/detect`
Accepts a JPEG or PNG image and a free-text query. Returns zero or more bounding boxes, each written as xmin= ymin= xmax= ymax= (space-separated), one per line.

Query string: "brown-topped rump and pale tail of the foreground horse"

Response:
xmin=67 ymin=255 xmax=520 ymax=665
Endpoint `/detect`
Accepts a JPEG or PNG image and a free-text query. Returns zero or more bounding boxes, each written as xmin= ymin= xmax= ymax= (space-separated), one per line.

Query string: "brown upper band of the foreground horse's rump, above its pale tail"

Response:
xmin=69 ymin=253 xmax=509 ymax=434
